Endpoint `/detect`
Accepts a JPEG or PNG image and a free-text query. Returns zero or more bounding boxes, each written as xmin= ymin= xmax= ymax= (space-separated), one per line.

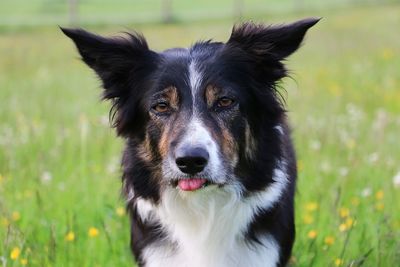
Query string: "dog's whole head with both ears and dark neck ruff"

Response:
xmin=62 ymin=19 xmax=318 ymax=203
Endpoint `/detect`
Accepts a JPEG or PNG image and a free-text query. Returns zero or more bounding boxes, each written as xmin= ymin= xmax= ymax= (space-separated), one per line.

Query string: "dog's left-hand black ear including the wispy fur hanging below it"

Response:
xmin=61 ymin=28 xmax=159 ymax=135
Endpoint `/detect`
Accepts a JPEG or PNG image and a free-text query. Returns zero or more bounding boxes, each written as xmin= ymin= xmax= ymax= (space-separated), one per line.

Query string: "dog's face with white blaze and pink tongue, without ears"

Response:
xmin=145 ymin=43 xmax=270 ymax=191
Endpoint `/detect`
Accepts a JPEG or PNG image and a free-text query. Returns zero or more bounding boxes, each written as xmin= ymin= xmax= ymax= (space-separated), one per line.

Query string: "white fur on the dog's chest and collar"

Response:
xmin=136 ymin=164 xmax=287 ymax=267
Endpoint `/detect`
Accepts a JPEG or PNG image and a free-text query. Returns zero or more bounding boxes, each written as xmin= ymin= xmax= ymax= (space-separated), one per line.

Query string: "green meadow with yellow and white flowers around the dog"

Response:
xmin=0 ymin=2 xmax=400 ymax=266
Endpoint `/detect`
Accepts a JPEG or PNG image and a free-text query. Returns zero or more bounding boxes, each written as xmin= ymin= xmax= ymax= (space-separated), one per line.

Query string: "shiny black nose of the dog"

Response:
xmin=175 ymin=147 xmax=209 ymax=174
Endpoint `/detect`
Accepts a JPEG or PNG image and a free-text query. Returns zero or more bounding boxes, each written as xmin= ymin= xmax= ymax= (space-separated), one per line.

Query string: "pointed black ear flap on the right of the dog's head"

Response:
xmin=227 ymin=18 xmax=320 ymax=60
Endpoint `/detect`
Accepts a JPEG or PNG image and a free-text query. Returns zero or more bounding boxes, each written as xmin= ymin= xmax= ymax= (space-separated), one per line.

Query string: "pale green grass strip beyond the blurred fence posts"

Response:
xmin=0 ymin=0 xmax=396 ymax=26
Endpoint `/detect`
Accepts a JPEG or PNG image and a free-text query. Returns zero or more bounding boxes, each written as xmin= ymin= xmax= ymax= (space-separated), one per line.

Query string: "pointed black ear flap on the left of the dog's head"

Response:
xmin=61 ymin=28 xmax=156 ymax=99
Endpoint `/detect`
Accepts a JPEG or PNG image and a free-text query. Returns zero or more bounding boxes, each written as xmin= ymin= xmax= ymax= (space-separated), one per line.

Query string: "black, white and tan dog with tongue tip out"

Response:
xmin=61 ymin=18 xmax=319 ymax=267
